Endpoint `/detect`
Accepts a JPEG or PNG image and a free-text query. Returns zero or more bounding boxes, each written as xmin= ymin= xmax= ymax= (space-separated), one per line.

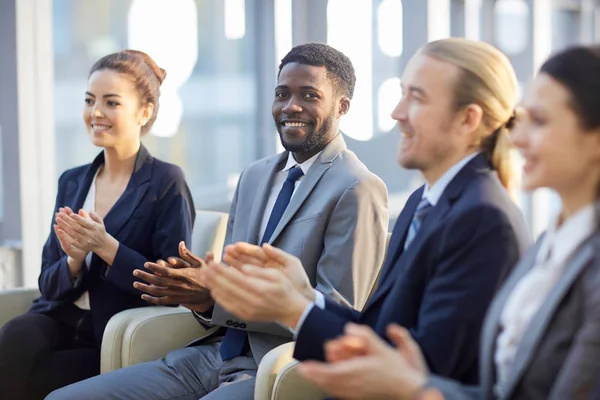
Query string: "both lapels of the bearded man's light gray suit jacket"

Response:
xmin=248 ymin=133 xmax=347 ymax=244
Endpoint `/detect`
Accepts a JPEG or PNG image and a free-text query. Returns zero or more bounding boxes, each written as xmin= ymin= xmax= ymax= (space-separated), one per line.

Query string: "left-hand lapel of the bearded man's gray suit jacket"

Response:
xmin=246 ymin=151 xmax=289 ymax=244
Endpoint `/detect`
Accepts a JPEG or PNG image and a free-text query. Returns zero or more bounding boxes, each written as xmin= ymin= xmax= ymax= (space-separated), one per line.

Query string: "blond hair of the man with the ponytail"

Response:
xmin=419 ymin=38 xmax=518 ymax=190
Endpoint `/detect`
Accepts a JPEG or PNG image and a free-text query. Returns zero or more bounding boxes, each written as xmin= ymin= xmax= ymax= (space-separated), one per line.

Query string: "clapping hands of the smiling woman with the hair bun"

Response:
xmin=53 ymin=207 xmax=119 ymax=278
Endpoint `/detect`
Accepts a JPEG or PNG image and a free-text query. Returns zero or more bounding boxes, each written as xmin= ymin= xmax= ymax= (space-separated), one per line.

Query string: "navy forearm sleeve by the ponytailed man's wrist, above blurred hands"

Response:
xmin=294 ymin=299 xmax=360 ymax=361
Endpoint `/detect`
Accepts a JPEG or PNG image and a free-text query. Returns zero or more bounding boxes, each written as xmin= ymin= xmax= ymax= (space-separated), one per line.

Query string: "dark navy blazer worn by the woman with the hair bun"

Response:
xmin=30 ymin=146 xmax=195 ymax=344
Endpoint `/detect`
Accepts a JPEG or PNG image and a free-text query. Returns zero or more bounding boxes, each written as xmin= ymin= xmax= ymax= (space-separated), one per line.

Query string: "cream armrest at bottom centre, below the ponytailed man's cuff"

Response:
xmin=254 ymin=342 xmax=328 ymax=400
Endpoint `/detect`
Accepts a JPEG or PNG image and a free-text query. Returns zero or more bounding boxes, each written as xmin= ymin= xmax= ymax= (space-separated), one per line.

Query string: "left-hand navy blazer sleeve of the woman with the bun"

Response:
xmin=38 ymin=173 xmax=87 ymax=301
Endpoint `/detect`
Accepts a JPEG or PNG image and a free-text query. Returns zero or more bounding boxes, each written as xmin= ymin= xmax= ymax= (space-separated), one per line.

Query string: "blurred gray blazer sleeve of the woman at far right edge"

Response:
xmin=548 ymin=253 xmax=600 ymax=399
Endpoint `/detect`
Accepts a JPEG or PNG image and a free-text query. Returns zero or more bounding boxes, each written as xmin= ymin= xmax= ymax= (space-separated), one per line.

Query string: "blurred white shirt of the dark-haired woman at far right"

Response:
xmin=494 ymin=205 xmax=596 ymax=391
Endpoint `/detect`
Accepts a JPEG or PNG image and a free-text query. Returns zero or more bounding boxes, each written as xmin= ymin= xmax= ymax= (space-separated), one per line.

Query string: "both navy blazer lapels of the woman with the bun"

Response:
xmin=61 ymin=145 xmax=153 ymax=237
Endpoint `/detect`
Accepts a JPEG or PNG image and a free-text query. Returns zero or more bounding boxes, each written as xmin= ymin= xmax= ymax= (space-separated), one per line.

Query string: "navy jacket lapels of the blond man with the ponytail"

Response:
xmin=365 ymin=154 xmax=492 ymax=311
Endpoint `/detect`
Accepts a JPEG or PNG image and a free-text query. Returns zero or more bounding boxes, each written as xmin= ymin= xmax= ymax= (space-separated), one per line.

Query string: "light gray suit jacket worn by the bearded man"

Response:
xmin=200 ymin=134 xmax=388 ymax=363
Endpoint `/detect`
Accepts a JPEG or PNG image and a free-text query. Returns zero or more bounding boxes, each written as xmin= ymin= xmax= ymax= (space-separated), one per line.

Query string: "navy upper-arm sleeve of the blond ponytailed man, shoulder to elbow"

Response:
xmin=410 ymin=206 xmax=520 ymax=379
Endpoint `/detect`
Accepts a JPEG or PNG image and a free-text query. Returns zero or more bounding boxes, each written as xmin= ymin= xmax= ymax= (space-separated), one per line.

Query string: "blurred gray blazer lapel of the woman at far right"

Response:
xmin=505 ymin=239 xmax=594 ymax=397
